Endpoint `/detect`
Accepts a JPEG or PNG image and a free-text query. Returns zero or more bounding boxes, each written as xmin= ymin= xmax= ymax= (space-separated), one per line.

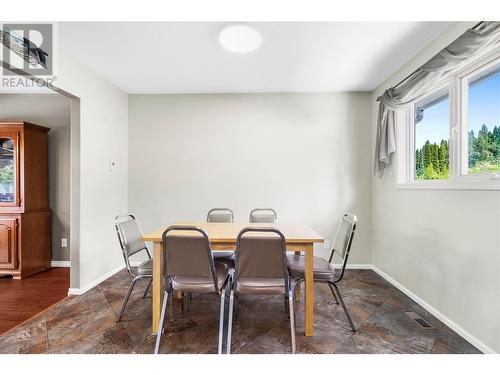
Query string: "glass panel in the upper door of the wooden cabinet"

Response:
xmin=0 ymin=136 xmax=16 ymax=204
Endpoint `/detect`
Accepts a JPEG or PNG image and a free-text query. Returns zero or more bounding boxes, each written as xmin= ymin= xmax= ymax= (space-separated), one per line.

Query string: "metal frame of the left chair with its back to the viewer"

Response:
xmin=154 ymin=225 xmax=231 ymax=354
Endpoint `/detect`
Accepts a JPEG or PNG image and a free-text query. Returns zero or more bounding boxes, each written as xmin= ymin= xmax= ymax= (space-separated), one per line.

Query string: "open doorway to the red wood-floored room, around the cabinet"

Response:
xmin=0 ymin=93 xmax=73 ymax=334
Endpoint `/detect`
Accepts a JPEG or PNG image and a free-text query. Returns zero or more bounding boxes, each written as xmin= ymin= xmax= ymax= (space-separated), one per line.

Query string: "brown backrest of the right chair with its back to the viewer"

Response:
xmin=235 ymin=227 xmax=288 ymax=293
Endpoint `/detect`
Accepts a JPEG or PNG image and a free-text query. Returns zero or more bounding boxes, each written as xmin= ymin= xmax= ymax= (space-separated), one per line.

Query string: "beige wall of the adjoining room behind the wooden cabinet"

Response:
xmin=0 ymin=94 xmax=70 ymax=261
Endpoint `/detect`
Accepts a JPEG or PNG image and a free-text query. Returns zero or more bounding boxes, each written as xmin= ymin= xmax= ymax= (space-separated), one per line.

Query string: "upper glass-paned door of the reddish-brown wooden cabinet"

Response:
xmin=0 ymin=131 xmax=21 ymax=207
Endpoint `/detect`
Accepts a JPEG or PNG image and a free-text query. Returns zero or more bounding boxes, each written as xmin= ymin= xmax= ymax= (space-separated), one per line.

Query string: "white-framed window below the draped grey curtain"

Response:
xmin=396 ymin=48 xmax=500 ymax=190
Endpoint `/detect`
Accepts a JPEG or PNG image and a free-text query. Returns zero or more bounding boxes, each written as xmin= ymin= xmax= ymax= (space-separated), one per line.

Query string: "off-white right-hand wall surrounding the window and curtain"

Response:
xmin=371 ymin=23 xmax=500 ymax=352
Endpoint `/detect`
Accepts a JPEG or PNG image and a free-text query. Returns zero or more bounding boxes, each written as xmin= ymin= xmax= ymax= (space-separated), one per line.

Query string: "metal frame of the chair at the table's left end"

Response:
xmin=114 ymin=214 xmax=153 ymax=322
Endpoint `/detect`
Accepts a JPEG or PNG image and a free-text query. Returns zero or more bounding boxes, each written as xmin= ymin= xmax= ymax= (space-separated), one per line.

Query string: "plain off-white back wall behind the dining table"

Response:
xmin=128 ymin=93 xmax=371 ymax=263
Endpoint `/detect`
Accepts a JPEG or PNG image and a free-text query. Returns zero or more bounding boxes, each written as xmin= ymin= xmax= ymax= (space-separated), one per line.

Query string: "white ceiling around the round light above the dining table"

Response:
xmin=58 ymin=22 xmax=451 ymax=94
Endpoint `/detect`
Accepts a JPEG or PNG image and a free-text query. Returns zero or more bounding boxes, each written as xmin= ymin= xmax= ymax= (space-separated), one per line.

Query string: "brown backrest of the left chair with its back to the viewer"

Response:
xmin=162 ymin=225 xmax=218 ymax=292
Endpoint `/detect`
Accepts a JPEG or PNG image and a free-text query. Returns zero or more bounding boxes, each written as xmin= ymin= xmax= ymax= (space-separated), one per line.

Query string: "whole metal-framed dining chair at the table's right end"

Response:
xmin=287 ymin=214 xmax=358 ymax=332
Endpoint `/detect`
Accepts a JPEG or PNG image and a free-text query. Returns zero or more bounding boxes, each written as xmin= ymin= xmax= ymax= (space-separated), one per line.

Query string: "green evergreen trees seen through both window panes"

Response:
xmin=415 ymin=124 xmax=500 ymax=180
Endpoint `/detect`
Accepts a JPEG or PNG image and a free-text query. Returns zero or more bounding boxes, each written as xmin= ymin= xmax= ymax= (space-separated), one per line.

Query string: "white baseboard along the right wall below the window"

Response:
xmin=371 ymin=265 xmax=496 ymax=354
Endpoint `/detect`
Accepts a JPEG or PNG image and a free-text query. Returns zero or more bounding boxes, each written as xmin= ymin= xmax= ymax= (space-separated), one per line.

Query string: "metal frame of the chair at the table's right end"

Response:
xmin=292 ymin=214 xmax=357 ymax=332
